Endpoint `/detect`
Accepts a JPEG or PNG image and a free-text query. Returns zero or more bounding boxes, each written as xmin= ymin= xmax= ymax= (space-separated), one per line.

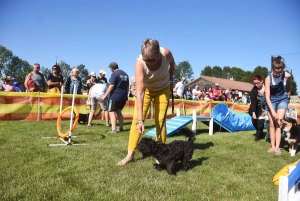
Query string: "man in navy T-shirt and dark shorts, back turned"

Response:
xmin=101 ymin=62 xmax=129 ymax=133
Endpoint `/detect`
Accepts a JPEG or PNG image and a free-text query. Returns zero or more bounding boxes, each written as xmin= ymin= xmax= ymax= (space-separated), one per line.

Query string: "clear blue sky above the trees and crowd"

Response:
xmin=0 ymin=0 xmax=300 ymax=91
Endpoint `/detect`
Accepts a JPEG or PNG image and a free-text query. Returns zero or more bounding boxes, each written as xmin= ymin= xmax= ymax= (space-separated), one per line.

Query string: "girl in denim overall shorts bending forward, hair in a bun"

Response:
xmin=265 ymin=56 xmax=291 ymax=155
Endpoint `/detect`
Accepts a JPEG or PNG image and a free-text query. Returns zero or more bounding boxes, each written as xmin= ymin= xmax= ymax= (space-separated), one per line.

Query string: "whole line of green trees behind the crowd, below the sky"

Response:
xmin=0 ymin=45 xmax=297 ymax=95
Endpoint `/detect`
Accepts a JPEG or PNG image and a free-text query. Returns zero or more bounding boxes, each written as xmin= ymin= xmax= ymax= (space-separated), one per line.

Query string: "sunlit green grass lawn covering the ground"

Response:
xmin=0 ymin=120 xmax=298 ymax=201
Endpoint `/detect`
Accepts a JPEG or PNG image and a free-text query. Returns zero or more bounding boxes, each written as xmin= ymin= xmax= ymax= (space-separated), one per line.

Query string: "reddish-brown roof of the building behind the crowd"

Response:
xmin=187 ymin=76 xmax=253 ymax=92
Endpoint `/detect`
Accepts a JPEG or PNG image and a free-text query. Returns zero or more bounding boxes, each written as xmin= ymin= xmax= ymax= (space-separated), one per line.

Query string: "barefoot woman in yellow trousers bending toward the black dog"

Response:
xmin=117 ymin=38 xmax=175 ymax=166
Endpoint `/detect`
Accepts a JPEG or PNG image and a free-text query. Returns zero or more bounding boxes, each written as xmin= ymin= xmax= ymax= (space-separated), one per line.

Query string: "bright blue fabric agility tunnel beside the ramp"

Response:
xmin=211 ymin=103 xmax=255 ymax=132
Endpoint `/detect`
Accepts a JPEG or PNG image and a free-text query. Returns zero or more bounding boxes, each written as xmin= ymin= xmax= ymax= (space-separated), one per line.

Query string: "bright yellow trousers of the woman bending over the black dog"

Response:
xmin=128 ymin=86 xmax=170 ymax=151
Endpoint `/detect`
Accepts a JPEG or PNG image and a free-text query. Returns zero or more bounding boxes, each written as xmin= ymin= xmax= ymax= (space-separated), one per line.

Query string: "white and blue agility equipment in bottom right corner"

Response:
xmin=278 ymin=162 xmax=300 ymax=201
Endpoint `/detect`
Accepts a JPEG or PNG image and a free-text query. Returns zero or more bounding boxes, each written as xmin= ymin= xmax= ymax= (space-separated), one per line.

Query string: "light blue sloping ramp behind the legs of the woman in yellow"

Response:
xmin=146 ymin=116 xmax=193 ymax=137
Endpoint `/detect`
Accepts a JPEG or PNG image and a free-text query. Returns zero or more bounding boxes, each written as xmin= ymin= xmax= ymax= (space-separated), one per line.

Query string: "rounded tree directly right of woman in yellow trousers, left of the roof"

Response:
xmin=173 ymin=61 xmax=194 ymax=84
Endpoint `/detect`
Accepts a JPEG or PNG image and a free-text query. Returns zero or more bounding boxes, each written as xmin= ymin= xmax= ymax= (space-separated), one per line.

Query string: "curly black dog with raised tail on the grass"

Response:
xmin=137 ymin=128 xmax=195 ymax=175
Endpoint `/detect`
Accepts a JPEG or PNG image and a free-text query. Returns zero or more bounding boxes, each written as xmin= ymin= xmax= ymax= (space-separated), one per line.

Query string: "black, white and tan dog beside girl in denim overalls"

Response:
xmin=281 ymin=117 xmax=300 ymax=156
